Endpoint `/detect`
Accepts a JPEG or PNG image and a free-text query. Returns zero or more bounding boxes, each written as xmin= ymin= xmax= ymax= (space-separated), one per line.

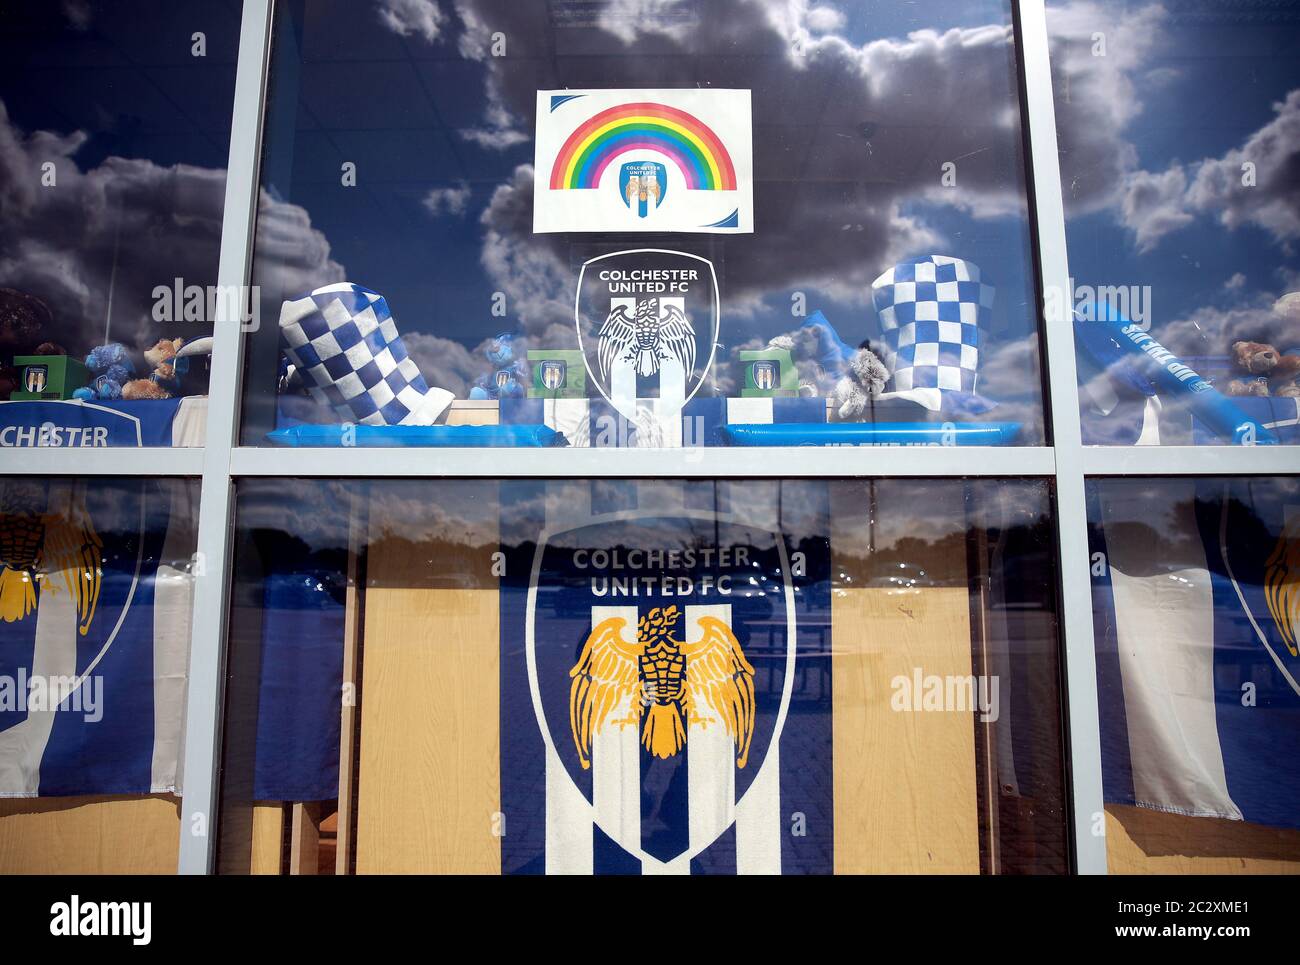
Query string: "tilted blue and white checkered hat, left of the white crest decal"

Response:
xmin=280 ymin=281 xmax=452 ymax=425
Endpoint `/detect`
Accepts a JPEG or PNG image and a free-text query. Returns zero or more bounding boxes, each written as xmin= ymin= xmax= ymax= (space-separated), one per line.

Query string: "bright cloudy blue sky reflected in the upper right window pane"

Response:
xmin=1048 ymin=0 xmax=1300 ymax=358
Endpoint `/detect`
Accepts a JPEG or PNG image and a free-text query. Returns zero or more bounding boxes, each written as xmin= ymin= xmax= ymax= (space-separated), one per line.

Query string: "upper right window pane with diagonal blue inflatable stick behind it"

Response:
xmin=1048 ymin=0 xmax=1300 ymax=445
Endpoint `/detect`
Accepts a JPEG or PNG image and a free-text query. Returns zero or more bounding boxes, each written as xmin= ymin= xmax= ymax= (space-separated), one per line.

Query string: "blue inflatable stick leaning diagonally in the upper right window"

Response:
xmin=1074 ymin=303 xmax=1278 ymax=446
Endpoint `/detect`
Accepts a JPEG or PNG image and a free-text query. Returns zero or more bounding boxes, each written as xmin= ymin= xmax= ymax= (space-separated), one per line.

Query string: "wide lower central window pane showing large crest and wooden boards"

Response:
xmin=218 ymin=480 xmax=1067 ymax=874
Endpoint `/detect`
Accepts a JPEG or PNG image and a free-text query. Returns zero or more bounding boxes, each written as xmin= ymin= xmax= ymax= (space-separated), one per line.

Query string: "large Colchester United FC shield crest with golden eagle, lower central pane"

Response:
xmin=517 ymin=502 xmax=797 ymax=871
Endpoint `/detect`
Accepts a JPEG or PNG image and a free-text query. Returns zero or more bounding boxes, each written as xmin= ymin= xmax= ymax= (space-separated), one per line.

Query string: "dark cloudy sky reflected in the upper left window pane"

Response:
xmin=0 ymin=0 xmax=241 ymax=364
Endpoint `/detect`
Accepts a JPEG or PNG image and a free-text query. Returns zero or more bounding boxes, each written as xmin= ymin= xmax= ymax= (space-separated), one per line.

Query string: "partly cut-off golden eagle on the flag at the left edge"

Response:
xmin=0 ymin=484 xmax=104 ymax=636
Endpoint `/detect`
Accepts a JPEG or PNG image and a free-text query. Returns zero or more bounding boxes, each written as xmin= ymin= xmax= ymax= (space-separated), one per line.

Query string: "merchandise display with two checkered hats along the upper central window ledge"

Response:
xmin=268 ymin=252 xmax=1019 ymax=447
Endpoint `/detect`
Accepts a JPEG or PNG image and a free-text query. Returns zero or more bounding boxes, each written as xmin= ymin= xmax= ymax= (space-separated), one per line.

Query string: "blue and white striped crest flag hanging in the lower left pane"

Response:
xmin=0 ymin=480 xmax=195 ymax=797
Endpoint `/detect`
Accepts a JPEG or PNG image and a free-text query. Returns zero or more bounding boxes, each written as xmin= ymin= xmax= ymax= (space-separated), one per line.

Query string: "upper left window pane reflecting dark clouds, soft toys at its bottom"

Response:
xmin=0 ymin=0 xmax=241 ymax=446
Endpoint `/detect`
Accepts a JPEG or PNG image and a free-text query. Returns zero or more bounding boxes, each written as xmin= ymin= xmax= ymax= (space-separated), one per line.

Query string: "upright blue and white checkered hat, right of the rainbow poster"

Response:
xmin=871 ymin=255 xmax=993 ymax=393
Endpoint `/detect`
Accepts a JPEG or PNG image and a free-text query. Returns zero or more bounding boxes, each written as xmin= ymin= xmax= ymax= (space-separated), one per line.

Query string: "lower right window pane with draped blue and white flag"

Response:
xmin=1088 ymin=479 xmax=1300 ymax=874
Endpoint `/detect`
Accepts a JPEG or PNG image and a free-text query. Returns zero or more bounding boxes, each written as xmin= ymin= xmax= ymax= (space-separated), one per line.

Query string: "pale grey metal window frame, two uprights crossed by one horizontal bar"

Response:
xmin=0 ymin=0 xmax=1300 ymax=874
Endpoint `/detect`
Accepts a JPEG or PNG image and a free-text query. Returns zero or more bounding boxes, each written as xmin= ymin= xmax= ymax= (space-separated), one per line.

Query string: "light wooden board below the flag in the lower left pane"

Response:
xmin=0 ymin=795 xmax=181 ymax=874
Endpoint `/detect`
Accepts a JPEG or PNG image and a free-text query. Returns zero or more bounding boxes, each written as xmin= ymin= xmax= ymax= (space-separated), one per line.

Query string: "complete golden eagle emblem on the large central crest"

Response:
xmin=569 ymin=606 xmax=754 ymax=770
